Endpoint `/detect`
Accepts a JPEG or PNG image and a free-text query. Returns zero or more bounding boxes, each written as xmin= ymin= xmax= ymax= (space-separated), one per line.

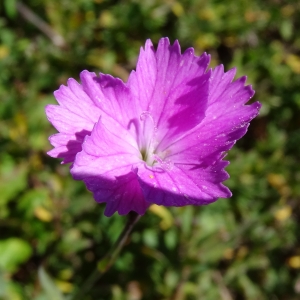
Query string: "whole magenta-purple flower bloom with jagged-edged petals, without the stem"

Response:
xmin=46 ymin=38 xmax=261 ymax=216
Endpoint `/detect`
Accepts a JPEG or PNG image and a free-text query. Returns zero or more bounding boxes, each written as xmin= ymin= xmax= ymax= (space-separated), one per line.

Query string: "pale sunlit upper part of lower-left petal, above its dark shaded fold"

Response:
xmin=71 ymin=119 xmax=141 ymax=180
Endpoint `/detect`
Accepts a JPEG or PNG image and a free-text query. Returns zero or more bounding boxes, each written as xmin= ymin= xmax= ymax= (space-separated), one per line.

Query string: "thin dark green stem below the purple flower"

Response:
xmin=72 ymin=211 xmax=141 ymax=300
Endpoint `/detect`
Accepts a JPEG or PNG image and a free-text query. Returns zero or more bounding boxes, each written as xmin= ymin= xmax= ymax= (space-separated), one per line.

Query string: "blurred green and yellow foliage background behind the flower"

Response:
xmin=0 ymin=0 xmax=300 ymax=300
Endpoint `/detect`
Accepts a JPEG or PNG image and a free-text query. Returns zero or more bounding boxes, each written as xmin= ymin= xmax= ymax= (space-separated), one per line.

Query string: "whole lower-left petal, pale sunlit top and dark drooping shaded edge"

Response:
xmin=71 ymin=120 xmax=149 ymax=216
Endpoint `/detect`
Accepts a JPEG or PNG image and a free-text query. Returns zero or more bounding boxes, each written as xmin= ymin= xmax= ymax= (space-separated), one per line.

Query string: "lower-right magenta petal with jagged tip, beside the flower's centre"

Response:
xmin=138 ymin=161 xmax=231 ymax=206
